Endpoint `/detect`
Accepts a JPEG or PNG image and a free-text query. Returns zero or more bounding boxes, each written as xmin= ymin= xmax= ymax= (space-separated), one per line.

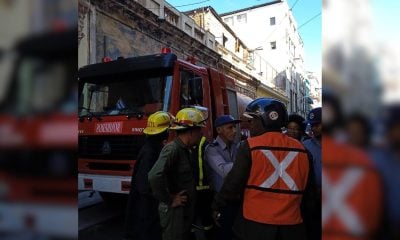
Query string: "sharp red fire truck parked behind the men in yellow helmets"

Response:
xmin=78 ymin=48 xmax=251 ymax=197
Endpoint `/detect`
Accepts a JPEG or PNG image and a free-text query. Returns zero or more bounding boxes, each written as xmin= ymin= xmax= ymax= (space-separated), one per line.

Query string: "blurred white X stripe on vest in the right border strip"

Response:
xmin=322 ymin=168 xmax=365 ymax=234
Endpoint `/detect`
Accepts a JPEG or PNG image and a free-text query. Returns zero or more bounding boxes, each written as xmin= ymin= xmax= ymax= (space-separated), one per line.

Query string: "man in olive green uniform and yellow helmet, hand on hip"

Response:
xmin=149 ymin=108 xmax=206 ymax=240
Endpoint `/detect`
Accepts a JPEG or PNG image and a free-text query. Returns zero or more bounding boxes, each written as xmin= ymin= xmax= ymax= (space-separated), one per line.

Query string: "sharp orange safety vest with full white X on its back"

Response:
xmin=243 ymin=132 xmax=310 ymax=225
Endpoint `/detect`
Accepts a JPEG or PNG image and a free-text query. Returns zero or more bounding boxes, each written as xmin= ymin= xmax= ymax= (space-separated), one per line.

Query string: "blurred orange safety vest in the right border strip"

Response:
xmin=321 ymin=137 xmax=383 ymax=240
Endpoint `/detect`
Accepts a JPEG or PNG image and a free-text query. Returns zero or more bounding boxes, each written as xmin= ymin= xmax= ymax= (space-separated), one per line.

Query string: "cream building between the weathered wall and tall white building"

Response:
xmin=185 ymin=6 xmax=288 ymax=103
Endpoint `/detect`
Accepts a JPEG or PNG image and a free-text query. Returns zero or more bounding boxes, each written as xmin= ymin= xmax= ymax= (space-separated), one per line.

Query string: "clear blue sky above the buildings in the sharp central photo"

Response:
xmin=167 ymin=0 xmax=322 ymax=74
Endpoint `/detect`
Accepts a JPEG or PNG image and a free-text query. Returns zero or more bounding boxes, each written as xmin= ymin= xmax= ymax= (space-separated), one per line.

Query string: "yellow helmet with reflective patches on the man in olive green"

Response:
xmin=171 ymin=108 xmax=207 ymax=130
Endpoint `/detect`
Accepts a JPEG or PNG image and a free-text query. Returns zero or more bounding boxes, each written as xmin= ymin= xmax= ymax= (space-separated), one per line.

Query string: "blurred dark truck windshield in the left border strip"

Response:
xmin=0 ymin=56 xmax=77 ymax=114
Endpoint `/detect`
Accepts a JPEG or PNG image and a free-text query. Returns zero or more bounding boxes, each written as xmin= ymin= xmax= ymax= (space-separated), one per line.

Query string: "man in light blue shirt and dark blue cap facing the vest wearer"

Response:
xmin=205 ymin=115 xmax=240 ymax=239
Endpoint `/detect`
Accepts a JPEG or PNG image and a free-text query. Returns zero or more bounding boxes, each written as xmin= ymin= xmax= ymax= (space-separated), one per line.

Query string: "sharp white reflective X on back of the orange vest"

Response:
xmin=260 ymin=150 xmax=299 ymax=191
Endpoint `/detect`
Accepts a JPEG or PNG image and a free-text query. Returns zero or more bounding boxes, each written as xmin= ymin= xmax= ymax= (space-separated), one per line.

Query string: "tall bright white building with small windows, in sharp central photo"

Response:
xmin=220 ymin=1 xmax=305 ymax=114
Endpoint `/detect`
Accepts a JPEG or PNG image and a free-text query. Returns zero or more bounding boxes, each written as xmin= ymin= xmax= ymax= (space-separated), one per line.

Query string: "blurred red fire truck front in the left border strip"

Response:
xmin=0 ymin=29 xmax=78 ymax=239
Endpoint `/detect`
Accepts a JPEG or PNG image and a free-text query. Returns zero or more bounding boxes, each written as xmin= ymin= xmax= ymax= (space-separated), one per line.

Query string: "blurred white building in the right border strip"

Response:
xmin=322 ymin=0 xmax=380 ymax=119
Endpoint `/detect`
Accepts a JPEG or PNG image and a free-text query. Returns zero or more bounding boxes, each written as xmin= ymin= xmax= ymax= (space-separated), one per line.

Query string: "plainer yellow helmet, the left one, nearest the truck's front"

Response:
xmin=143 ymin=111 xmax=171 ymax=135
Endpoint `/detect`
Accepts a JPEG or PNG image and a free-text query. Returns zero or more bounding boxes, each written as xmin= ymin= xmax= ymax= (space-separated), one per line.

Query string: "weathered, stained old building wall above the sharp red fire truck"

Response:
xmin=80 ymin=0 xmax=219 ymax=66
